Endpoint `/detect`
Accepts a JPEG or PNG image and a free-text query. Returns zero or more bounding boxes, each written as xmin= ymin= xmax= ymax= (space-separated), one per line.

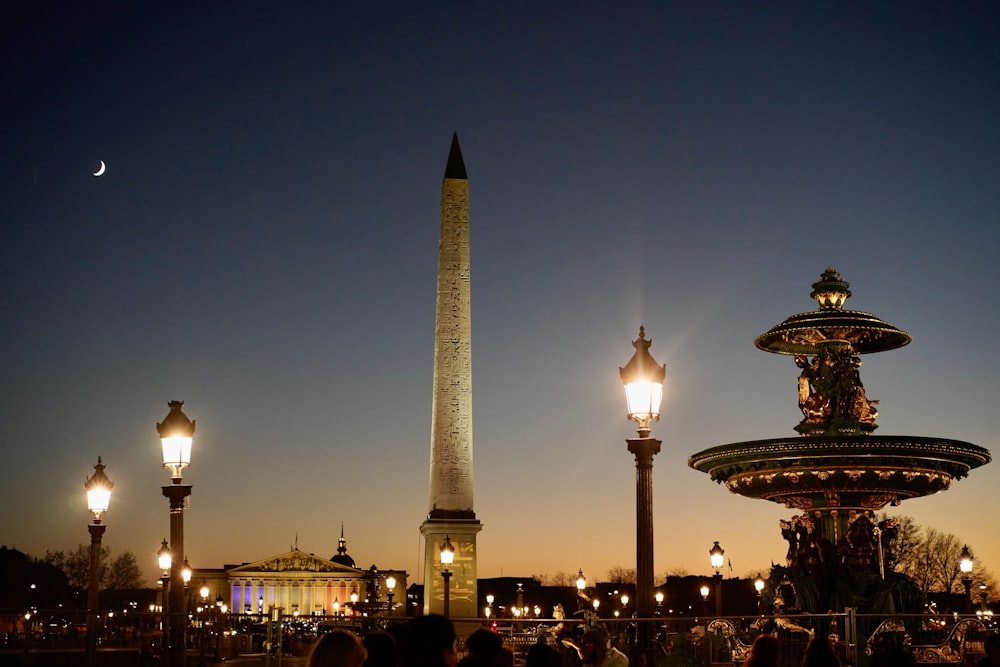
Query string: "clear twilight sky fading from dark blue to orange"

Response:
xmin=0 ymin=0 xmax=1000 ymax=582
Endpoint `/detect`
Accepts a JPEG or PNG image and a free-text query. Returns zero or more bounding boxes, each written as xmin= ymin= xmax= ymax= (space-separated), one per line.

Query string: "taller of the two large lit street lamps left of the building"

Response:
xmin=156 ymin=401 xmax=195 ymax=667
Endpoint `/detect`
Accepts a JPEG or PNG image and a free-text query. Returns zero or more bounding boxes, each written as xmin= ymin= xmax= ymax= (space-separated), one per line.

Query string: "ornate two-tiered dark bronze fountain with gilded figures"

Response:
xmin=688 ymin=268 xmax=991 ymax=613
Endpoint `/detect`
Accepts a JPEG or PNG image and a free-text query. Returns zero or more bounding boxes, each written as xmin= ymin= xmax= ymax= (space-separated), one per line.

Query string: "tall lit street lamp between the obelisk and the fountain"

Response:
xmin=618 ymin=326 xmax=667 ymax=662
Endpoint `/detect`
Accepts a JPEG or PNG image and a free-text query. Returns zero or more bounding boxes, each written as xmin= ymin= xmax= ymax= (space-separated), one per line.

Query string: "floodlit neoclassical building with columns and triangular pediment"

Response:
xmin=189 ymin=532 xmax=407 ymax=616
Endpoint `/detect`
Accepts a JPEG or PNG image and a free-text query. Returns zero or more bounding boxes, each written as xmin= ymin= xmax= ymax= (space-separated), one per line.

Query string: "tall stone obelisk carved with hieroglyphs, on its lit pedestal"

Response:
xmin=420 ymin=134 xmax=482 ymax=618
